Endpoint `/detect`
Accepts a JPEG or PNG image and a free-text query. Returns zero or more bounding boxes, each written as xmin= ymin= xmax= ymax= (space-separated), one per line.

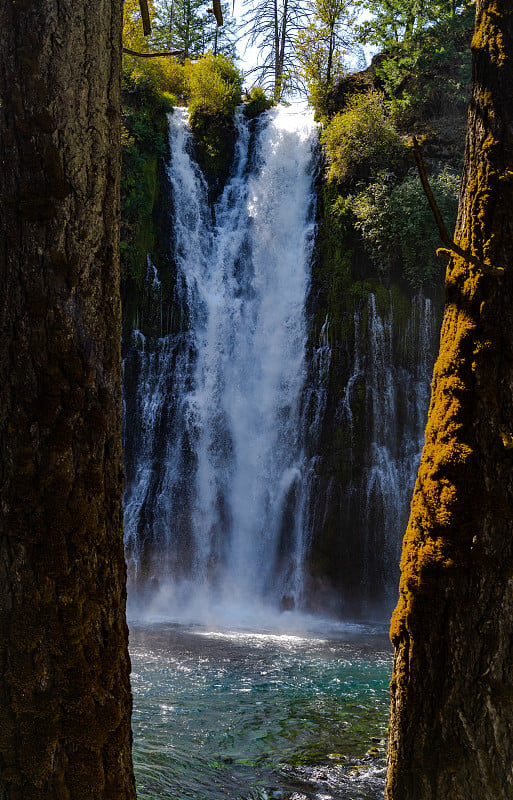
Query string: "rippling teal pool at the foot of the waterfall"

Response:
xmin=130 ymin=624 xmax=391 ymax=800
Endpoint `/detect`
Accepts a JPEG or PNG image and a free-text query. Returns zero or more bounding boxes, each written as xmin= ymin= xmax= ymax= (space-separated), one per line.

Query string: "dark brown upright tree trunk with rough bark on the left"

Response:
xmin=0 ymin=0 xmax=135 ymax=800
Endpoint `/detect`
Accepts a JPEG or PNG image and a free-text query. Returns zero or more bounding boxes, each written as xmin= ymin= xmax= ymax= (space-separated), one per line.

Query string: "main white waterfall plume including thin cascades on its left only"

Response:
xmin=125 ymin=107 xmax=316 ymax=611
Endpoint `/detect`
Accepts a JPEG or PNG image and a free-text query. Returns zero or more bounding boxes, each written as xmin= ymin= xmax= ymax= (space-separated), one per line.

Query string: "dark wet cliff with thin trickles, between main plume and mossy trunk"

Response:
xmin=309 ymin=287 xmax=439 ymax=615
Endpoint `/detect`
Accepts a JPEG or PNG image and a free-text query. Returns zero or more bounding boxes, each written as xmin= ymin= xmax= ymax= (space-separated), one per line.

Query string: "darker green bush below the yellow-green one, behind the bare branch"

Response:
xmin=351 ymin=170 xmax=459 ymax=289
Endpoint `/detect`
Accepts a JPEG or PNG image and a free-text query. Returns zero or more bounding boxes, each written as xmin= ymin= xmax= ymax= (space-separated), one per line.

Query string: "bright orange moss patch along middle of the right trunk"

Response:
xmin=390 ymin=306 xmax=476 ymax=645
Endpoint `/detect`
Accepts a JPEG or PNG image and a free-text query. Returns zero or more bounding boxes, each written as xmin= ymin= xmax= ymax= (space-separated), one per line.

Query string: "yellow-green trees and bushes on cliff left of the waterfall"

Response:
xmin=121 ymin=0 xmax=250 ymax=318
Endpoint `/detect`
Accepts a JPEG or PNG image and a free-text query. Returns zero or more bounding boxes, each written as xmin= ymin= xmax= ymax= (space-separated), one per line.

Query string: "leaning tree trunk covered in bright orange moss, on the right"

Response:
xmin=386 ymin=0 xmax=513 ymax=800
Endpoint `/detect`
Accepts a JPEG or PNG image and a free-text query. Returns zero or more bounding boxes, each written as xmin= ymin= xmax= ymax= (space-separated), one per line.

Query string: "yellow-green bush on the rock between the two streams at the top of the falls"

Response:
xmin=185 ymin=53 xmax=242 ymax=122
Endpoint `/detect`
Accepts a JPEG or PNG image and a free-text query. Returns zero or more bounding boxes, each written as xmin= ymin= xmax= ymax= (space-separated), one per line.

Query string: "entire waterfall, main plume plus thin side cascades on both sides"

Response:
xmin=124 ymin=107 xmax=439 ymax=621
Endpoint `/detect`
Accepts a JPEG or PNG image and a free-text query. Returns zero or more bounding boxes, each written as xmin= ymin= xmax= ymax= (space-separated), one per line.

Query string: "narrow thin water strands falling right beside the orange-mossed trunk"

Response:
xmin=362 ymin=294 xmax=434 ymax=598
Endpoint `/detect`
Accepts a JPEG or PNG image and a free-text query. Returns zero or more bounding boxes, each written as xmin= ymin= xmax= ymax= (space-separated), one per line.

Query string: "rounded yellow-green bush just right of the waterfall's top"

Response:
xmin=321 ymin=89 xmax=406 ymax=181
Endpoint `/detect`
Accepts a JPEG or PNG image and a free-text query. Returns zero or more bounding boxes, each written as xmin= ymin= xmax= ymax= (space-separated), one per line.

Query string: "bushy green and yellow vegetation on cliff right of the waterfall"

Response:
xmin=317 ymin=9 xmax=473 ymax=290
